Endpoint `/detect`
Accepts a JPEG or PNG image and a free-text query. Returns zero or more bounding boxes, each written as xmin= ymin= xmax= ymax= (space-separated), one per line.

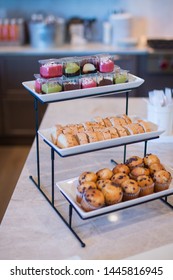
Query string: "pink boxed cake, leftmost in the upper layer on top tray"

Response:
xmin=40 ymin=59 xmax=63 ymax=79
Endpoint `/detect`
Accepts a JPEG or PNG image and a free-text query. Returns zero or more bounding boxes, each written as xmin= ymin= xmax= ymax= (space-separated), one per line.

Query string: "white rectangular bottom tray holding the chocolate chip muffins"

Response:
xmin=56 ymin=166 xmax=173 ymax=219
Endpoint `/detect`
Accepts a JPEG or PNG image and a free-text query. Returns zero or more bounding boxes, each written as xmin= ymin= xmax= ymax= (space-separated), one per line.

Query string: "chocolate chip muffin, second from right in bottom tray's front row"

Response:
xmin=136 ymin=175 xmax=154 ymax=196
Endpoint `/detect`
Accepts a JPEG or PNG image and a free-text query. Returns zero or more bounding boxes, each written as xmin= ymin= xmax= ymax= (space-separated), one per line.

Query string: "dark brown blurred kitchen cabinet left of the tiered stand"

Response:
xmin=0 ymin=55 xmax=46 ymax=144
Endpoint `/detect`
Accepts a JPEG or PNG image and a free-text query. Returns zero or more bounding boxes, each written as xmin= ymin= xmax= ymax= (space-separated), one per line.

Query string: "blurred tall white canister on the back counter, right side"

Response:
xmin=109 ymin=13 xmax=132 ymax=46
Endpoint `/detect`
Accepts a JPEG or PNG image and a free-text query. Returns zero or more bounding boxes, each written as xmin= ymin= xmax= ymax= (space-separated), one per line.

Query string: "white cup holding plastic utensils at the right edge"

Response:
xmin=147 ymin=103 xmax=173 ymax=135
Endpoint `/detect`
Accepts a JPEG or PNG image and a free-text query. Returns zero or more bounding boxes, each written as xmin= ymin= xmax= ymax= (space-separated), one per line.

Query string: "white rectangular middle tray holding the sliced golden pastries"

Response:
xmin=38 ymin=122 xmax=164 ymax=157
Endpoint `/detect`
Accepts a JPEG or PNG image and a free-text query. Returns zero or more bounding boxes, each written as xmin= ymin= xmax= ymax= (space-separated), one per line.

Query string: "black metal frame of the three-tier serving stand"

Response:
xmin=29 ymin=91 xmax=173 ymax=247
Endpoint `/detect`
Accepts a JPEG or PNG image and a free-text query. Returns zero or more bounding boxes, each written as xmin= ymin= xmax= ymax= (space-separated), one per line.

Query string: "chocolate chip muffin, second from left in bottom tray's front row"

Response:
xmin=102 ymin=183 xmax=123 ymax=205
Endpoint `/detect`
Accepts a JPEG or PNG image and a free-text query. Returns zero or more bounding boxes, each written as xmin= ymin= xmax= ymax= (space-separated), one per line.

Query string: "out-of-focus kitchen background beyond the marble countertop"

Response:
xmin=0 ymin=0 xmax=173 ymax=221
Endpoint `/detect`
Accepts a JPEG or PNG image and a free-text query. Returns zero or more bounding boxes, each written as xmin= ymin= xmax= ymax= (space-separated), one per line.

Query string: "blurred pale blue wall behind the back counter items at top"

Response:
xmin=0 ymin=0 xmax=173 ymax=42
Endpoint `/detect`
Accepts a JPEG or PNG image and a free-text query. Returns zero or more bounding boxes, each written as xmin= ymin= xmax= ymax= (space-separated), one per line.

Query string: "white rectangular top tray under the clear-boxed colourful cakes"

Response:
xmin=22 ymin=74 xmax=144 ymax=103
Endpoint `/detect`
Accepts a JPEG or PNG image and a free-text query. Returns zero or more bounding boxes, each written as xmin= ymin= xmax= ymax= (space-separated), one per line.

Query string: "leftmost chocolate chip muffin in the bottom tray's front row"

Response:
xmin=81 ymin=189 xmax=105 ymax=212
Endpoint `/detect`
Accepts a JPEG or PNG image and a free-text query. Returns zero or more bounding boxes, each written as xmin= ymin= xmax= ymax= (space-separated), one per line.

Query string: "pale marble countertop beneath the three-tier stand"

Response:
xmin=0 ymin=97 xmax=173 ymax=260
